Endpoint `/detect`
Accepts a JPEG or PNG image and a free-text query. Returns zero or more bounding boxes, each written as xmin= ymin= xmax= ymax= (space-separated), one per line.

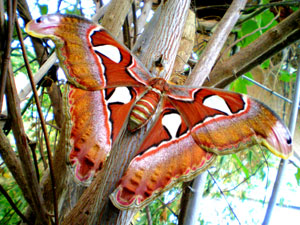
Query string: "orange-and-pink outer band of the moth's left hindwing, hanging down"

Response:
xmin=68 ymin=87 xmax=112 ymax=181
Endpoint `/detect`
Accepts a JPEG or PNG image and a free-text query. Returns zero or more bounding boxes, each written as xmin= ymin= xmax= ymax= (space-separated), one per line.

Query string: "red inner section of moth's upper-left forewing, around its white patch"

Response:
xmin=88 ymin=26 xmax=151 ymax=87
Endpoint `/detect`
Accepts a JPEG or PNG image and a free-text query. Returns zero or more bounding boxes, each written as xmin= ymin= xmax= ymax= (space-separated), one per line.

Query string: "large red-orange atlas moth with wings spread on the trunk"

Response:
xmin=26 ymin=14 xmax=292 ymax=209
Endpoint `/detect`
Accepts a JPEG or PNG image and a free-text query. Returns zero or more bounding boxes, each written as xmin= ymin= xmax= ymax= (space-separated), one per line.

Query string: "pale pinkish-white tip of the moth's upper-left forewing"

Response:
xmin=25 ymin=14 xmax=62 ymax=39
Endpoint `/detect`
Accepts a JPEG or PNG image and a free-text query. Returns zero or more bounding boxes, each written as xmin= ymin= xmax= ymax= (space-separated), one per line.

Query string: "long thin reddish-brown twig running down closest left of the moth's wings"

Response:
xmin=16 ymin=20 xmax=58 ymax=225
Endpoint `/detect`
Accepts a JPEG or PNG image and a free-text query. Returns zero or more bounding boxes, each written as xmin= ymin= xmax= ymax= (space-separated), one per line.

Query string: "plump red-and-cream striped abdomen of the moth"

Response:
xmin=128 ymin=88 xmax=161 ymax=132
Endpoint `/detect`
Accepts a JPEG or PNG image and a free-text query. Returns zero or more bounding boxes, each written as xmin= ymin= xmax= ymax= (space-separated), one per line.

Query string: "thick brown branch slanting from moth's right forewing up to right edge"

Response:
xmin=204 ymin=10 xmax=300 ymax=87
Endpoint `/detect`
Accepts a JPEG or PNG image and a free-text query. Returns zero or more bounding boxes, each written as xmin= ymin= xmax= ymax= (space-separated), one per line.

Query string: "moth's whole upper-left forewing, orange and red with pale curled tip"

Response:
xmin=26 ymin=14 xmax=151 ymax=91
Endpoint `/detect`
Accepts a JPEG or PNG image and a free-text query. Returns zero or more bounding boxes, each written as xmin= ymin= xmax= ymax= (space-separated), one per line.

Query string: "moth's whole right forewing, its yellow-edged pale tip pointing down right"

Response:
xmin=169 ymin=88 xmax=292 ymax=158
